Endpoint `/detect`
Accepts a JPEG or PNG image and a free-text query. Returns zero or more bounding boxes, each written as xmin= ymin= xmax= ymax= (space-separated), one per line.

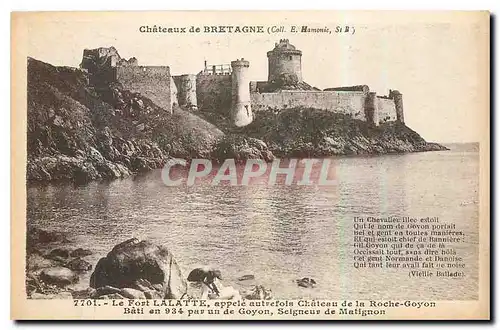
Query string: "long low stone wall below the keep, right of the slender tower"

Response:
xmin=251 ymin=91 xmax=367 ymax=120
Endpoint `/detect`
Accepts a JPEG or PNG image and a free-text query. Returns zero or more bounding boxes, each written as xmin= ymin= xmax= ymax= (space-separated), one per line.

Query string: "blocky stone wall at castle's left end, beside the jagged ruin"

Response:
xmin=115 ymin=66 xmax=173 ymax=113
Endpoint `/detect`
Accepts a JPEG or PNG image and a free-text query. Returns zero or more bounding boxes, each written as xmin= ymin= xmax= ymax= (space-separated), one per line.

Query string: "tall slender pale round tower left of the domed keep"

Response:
xmin=231 ymin=58 xmax=253 ymax=127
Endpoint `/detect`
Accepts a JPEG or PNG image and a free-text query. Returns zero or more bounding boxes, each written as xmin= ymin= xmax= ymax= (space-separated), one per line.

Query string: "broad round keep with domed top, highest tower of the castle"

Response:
xmin=267 ymin=39 xmax=302 ymax=83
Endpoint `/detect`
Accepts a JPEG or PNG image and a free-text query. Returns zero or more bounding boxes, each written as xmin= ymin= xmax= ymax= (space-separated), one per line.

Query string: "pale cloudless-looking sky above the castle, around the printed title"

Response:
xmin=21 ymin=12 xmax=488 ymax=142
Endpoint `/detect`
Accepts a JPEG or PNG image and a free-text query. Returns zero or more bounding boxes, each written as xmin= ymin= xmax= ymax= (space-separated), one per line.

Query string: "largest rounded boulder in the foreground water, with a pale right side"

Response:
xmin=90 ymin=238 xmax=187 ymax=299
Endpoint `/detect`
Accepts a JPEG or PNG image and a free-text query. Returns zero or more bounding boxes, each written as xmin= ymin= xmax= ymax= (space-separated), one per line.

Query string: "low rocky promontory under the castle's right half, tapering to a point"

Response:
xmin=236 ymin=108 xmax=447 ymax=157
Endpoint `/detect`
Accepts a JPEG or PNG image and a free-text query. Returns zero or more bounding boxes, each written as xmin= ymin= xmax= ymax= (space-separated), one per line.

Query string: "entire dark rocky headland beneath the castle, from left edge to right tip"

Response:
xmin=27 ymin=58 xmax=445 ymax=182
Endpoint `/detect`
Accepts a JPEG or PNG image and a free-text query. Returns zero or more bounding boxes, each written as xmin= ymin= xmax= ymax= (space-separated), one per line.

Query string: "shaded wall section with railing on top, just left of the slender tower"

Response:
xmin=196 ymin=74 xmax=232 ymax=115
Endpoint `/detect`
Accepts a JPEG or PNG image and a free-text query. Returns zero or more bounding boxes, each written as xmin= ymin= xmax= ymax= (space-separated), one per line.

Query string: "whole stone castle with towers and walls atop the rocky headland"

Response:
xmin=80 ymin=39 xmax=404 ymax=127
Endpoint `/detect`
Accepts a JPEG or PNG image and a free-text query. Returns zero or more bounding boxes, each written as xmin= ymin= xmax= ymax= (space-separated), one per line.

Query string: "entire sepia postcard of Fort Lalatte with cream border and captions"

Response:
xmin=11 ymin=11 xmax=490 ymax=320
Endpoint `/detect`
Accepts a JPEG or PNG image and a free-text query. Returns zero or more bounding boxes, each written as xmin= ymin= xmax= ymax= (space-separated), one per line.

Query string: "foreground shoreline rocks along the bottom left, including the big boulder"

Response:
xmin=26 ymin=228 xmax=278 ymax=300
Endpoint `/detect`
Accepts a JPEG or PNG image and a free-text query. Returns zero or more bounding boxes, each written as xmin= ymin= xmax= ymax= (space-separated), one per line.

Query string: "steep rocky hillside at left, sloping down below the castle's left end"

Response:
xmin=27 ymin=58 xmax=224 ymax=182
